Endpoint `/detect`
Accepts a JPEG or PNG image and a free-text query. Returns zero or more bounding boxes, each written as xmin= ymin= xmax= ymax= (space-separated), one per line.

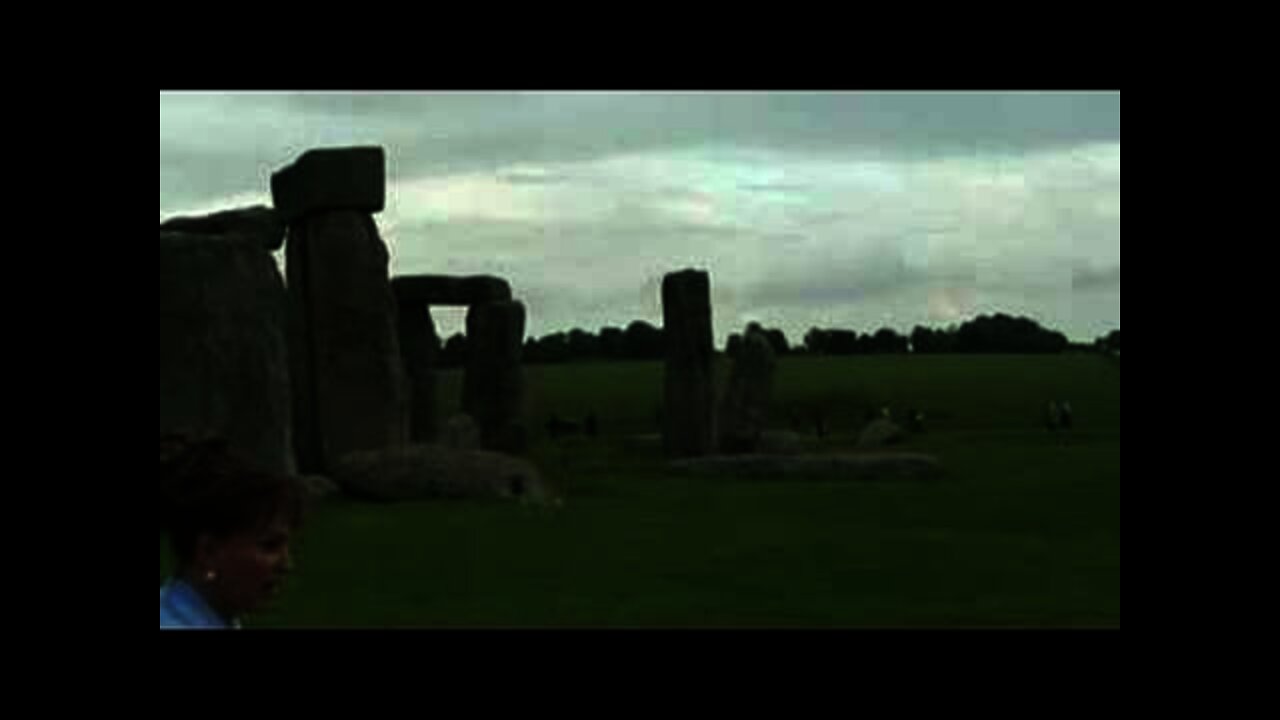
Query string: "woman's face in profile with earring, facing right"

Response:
xmin=201 ymin=519 xmax=293 ymax=618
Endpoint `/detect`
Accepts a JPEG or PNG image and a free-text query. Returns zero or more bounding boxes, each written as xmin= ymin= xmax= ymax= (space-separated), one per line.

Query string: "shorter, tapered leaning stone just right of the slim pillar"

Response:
xmin=721 ymin=331 xmax=777 ymax=455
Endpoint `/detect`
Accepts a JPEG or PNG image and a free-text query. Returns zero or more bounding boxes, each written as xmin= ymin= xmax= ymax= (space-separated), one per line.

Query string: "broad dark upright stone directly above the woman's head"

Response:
xmin=160 ymin=231 xmax=296 ymax=474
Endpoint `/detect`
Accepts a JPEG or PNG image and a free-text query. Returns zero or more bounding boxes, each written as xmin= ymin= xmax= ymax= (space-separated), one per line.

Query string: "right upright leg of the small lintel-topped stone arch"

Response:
xmin=462 ymin=301 xmax=526 ymax=454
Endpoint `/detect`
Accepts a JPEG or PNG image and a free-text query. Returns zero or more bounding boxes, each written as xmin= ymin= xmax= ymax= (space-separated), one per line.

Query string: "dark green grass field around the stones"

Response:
xmin=160 ymin=355 xmax=1120 ymax=628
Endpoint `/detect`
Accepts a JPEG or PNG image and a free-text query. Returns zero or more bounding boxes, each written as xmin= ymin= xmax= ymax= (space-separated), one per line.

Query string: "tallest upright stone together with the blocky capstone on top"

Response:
xmin=271 ymin=147 xmax=410 ymax=473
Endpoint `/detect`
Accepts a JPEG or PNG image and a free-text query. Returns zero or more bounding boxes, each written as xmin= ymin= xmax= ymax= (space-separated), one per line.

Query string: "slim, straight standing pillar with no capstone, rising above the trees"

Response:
xmin=662 ymin=270 xmax=716 ymax=459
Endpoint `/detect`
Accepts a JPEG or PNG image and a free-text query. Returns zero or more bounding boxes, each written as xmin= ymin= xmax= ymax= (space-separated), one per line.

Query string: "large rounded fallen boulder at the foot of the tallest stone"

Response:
xmin=335 ymin=445 xmax=553 ymax=502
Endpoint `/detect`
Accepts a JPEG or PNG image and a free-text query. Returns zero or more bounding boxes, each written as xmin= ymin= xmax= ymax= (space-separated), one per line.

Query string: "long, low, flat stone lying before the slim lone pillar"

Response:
xmin=667 ymin=452 xmax=942 ymax=482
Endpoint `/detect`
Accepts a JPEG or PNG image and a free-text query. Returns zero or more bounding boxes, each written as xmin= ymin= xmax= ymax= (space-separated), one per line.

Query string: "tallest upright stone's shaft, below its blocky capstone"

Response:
xmin=285 ymin=211 xmax=408 ymax=474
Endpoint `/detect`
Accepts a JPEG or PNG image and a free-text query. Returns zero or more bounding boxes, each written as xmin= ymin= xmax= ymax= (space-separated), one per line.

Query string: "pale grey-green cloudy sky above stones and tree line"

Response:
xmin=160 ymin=92 xmax=1120 ymax=345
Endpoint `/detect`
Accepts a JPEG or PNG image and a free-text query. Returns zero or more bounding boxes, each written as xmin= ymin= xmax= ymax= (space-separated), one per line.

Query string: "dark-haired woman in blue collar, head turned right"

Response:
xmin=160 ymin=437 xmax=302 ymax=629
